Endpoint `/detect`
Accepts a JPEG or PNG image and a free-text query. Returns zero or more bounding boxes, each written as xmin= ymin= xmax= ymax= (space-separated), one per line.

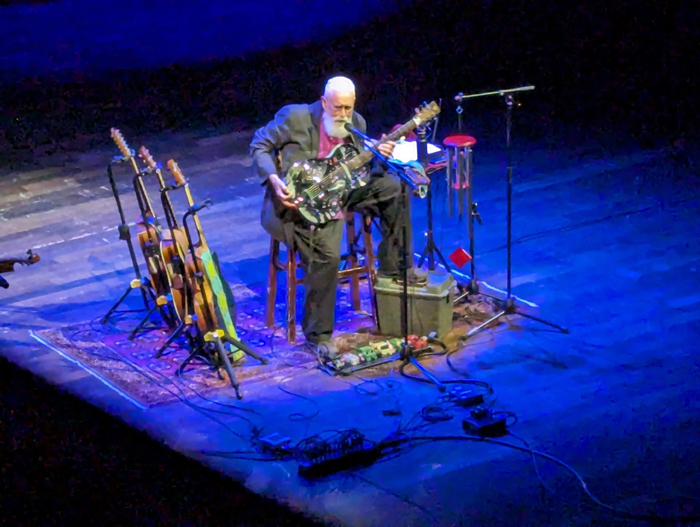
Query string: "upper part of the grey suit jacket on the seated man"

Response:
xmin=250 ymin=101 xmax=367 ymax=180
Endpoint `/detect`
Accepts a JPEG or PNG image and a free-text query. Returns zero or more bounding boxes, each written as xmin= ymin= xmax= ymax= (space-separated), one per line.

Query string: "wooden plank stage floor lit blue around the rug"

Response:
xmin=0 ymin=129 xmax=700 ymax=527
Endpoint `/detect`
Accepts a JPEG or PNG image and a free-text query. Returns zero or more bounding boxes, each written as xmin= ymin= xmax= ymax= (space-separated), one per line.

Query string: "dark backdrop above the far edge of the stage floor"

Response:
xmin=0 ymin=0 xmax=700 ymax=167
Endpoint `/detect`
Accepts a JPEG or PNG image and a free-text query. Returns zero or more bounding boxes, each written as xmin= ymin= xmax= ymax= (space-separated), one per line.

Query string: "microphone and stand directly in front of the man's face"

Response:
xmin=346 ymin=125 xmax=447 ymax=392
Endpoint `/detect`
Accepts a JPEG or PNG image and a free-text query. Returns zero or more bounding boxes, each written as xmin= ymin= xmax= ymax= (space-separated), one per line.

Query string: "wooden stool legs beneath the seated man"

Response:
xmin=265 ymin=212 xmax=377 ymax=343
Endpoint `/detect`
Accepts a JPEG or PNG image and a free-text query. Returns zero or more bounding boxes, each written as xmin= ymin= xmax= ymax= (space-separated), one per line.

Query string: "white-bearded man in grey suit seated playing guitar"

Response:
xmin=250 ymin=77 xmax=426 ymax=358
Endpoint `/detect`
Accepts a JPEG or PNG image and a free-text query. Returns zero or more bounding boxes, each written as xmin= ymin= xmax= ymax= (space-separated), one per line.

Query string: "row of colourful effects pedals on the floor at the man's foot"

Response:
xmin=321 ymin=335 xmax=429 ymax=375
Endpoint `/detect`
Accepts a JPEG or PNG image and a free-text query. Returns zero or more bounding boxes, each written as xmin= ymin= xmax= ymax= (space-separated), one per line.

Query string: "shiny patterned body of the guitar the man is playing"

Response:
xmin=285 ymin=144 xmax=369 ymax=225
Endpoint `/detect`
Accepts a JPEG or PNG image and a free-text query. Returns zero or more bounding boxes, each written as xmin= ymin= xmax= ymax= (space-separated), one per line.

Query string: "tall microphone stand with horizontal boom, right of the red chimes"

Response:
xmin=455 ymin=86 xmax=569 ymax=340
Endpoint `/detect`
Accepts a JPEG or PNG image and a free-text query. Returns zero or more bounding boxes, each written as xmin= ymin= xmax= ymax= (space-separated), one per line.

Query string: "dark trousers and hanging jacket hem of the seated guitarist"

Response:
xmin=261 ymin=175 xmax=413 ymax=342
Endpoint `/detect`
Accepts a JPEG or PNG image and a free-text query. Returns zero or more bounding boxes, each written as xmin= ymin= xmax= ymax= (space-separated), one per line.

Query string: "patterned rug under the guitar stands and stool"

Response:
xmin=31 ymin=283 xmax=493 ymax=407
